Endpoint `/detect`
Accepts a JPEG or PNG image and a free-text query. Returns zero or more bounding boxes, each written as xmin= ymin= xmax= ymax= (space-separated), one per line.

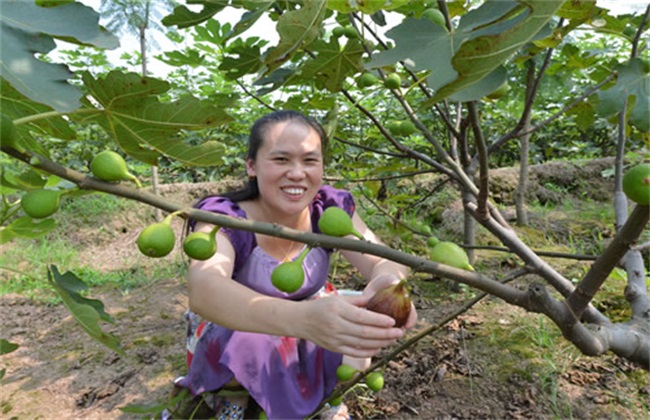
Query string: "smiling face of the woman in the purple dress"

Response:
xmin=246 ymin=120 xmax=323 ymax=215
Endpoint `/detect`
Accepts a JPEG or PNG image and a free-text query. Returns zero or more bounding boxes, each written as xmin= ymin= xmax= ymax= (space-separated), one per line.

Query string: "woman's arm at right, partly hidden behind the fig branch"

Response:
xmin=341 ymin=213 xmax=417 ymax=328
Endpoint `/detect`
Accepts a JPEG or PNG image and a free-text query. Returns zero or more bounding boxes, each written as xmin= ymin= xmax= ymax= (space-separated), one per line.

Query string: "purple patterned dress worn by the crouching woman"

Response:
xmin=177 ymin=186 xmax=355 ymax=419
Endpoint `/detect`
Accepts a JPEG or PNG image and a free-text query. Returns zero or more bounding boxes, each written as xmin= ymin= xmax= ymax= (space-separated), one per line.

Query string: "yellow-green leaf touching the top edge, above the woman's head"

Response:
xmin=264 ymin=0 xmax=327 ymax=73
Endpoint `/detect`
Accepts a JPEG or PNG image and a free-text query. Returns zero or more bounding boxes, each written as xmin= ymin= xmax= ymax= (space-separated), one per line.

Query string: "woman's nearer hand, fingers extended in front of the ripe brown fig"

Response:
xmin=293 ymin=295 xmax=404 ymax=358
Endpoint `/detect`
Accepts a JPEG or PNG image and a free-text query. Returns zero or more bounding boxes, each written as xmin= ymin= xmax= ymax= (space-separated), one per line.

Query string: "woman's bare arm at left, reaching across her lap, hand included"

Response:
xmin=188 ymin=223 xmax=403 ymax=357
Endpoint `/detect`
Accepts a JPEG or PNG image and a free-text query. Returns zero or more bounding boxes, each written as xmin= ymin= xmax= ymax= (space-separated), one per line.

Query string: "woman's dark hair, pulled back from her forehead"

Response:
xmin=221 ymin=110 xmax=327 ymax=202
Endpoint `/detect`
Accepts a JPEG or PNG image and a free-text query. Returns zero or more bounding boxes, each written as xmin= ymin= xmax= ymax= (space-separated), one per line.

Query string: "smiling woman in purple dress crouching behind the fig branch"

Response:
xmin=172 ymin=111 xmax=416 ymax=419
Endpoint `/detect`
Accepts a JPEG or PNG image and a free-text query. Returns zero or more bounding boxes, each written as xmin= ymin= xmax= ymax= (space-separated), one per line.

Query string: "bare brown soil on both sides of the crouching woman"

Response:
xmin=0 ymin=162 xmax=650 ymax=419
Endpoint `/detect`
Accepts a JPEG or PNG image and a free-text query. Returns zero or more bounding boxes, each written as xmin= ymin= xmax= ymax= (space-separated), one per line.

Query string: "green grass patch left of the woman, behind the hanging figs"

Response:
xmin=0 ymin=194 xmax=185 ymax=304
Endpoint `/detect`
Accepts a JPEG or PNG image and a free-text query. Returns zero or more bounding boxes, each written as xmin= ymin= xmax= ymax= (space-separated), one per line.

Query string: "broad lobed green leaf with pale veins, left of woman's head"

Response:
xmin=75 ymin=71 xmax=232 ymax=166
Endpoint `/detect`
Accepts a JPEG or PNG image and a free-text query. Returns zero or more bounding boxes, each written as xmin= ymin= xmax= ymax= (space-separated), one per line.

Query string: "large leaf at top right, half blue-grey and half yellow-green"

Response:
xmin=368 ymin=0 xmax=563 ymax=105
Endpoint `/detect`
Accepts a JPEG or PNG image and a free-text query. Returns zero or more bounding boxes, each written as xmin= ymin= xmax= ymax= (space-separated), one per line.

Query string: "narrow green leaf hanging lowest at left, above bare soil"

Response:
xmin=47 ymin=265 xmax=124 ymax=354
